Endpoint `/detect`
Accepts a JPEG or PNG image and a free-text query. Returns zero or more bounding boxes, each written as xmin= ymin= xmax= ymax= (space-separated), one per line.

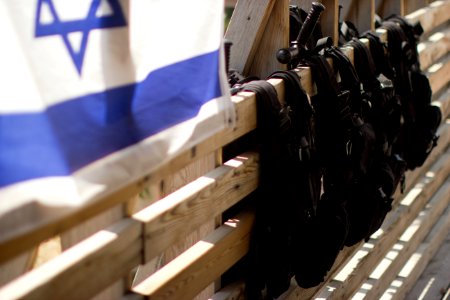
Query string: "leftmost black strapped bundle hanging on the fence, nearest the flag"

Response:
xmin=242 ymin=71 xmax=321 ymax=299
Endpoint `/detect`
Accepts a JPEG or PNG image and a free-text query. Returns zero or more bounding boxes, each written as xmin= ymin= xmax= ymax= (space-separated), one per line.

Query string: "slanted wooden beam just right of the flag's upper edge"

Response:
xmin=225 ymin=0 xmax=275 ymax=75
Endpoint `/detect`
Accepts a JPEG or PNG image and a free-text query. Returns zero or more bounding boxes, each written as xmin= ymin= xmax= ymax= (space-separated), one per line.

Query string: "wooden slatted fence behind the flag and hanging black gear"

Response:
xmin=0 ymin=0 xmax=450 ymax=300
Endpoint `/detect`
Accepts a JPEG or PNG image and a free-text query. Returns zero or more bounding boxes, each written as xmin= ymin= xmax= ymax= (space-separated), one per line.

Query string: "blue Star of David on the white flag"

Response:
xmin=35 ymin=0 xmax=127 ymax=75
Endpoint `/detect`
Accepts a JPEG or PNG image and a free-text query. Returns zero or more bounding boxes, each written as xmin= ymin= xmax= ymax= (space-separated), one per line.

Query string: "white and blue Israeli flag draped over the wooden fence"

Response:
xmin=0 ymin=0 xmax=234 ymax=237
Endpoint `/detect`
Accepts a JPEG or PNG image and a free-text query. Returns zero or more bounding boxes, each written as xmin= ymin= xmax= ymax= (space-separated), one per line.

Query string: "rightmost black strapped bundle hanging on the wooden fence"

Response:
xmin=381 ymin=15 xmax=442 ymax=170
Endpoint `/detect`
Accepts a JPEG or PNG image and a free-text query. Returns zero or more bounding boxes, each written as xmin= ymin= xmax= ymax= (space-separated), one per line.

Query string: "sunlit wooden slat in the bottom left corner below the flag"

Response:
xmin=0 ymin=219 xmax=142 ymax=300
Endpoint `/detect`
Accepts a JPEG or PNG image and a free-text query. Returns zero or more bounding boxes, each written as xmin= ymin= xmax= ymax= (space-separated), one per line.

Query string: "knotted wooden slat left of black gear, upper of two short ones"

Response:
xmin=133 ymin=153 xmax=258 ymax=262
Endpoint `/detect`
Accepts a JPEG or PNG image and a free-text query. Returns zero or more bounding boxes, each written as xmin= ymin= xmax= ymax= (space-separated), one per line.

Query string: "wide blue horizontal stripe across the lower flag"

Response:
xmin=0 ymin=51 xmax=221 ymax=186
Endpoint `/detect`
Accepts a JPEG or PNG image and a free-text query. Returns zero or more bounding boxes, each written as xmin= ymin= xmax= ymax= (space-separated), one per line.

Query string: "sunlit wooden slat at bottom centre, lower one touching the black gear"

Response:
xmin=133 ymin=211 xmax=254 ymax=300
